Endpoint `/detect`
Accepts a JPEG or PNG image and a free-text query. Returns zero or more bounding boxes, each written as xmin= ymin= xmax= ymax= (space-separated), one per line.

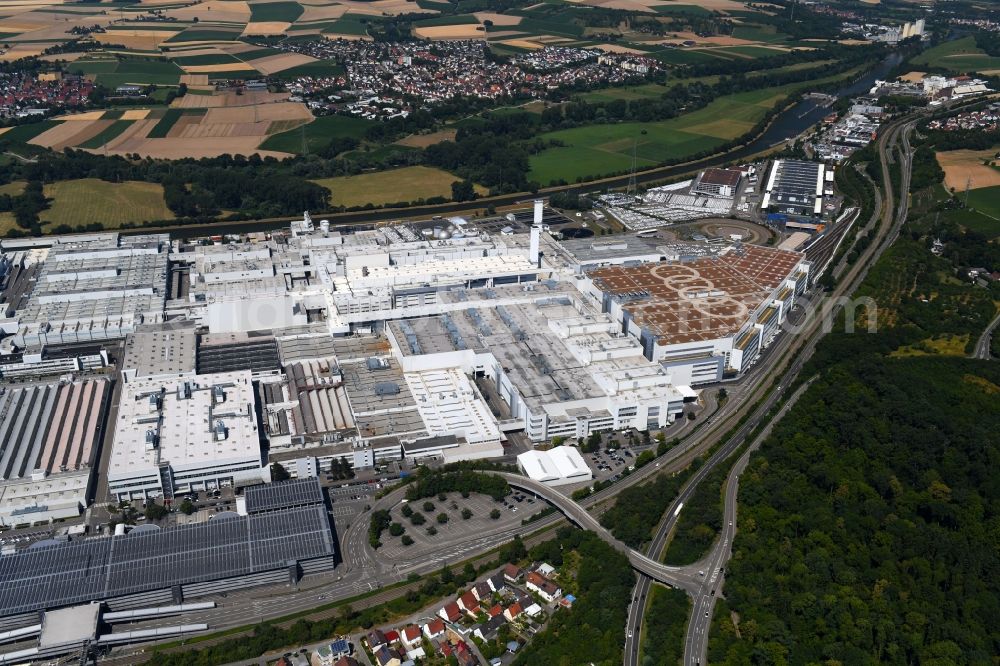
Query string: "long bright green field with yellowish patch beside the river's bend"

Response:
xmin=529 ymin=84 xmax=802 ymax=185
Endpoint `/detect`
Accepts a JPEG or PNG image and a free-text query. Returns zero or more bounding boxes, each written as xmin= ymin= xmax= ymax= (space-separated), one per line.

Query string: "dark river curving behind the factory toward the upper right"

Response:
xmin=135 ymin=53 xmax=903 ymax=238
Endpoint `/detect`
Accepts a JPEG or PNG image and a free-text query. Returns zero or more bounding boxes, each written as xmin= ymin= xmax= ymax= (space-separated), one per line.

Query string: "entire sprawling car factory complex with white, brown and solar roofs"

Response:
xmin=0 ymin=197 xmax=811 ymax=662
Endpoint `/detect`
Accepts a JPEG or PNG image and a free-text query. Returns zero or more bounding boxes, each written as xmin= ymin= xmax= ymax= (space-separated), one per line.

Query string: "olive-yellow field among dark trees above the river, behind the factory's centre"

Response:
xmin=313 ymin=166 xmax=486 ymax=207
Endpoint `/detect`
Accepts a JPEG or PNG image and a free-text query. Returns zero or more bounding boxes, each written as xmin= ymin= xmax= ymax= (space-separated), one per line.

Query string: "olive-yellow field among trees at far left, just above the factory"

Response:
xmin=38 ymin=178 xmax=174 ymax=229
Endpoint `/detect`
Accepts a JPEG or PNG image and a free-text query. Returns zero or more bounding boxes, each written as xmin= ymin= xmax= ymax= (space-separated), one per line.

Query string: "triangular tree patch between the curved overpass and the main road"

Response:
xmin=601 ymin=458 xmax=702 ymax=550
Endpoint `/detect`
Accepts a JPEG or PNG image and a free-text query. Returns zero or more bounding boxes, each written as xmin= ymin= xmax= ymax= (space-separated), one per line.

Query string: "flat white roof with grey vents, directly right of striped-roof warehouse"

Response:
xmin=109 ymin=370 xmax=260 ymax=478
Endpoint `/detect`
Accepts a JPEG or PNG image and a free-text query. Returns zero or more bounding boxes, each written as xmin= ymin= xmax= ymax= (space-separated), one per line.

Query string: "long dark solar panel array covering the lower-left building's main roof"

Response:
xmin=0 ymin=503 xmax=335 ymax=617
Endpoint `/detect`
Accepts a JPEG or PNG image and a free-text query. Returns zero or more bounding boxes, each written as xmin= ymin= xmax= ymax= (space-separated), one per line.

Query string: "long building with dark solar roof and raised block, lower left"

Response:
xmin=0 ymin=479 xmax=336 ymax=631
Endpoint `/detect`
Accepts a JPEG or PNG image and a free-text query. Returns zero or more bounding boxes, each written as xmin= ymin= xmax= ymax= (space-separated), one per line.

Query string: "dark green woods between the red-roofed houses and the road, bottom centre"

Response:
xmin=513 ymin=528 xmax=635 ymax=666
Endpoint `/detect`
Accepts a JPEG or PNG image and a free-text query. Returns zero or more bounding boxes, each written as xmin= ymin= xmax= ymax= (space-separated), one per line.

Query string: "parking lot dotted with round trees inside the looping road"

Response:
xmin=378 ymin=493 xmax=532 ymax=561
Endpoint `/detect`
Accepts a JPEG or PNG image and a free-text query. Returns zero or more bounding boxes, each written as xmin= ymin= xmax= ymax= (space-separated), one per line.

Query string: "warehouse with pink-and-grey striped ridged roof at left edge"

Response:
xmin=0 ymin=379 xmax=108 ymax=526
